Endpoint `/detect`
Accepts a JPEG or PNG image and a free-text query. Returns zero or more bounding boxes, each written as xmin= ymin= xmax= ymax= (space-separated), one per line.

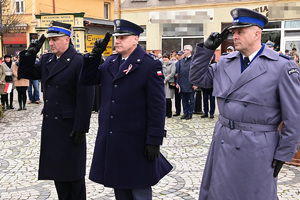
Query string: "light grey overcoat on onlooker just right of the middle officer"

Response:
xmin=163 ymin=60 xmax=176 ymax=99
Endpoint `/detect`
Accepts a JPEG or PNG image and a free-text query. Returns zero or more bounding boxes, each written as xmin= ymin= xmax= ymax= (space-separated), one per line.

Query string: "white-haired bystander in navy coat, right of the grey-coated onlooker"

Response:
xmin=176 ymin=45 xmax=198 ymax=120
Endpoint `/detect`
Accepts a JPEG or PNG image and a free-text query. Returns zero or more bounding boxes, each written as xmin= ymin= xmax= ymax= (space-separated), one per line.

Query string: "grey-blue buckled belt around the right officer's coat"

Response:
xmin=219 ymin=115 xmax=278 ymax=132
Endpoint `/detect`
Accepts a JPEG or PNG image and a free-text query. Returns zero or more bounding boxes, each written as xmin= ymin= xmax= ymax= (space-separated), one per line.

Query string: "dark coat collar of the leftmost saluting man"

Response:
xmin=46 ymin=45 xmax=76 ymax=79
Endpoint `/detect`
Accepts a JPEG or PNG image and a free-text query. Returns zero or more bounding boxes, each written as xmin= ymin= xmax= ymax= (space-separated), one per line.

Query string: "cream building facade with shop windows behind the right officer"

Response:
xmin=115 ymin=0 xmax=300 ymax=56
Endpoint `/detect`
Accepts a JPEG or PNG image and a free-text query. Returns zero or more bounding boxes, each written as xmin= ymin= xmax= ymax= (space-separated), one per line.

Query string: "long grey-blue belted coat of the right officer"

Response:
xmin=190 ymin=44 xmax=300 ymax=200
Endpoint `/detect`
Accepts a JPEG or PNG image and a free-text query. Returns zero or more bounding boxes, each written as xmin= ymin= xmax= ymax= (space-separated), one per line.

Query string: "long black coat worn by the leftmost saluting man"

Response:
xmin=18 ymin=46 xmax=94 ymax=181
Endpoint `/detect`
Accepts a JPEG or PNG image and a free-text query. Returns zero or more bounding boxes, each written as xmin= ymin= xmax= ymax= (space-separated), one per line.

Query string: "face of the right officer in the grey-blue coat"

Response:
xmin=232 ymin=26 xmax=261 ymax=52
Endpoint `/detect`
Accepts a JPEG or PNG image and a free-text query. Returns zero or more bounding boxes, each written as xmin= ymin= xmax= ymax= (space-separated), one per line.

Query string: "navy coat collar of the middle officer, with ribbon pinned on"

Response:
xmin=108 ymin=45 xmax=146 ymax=80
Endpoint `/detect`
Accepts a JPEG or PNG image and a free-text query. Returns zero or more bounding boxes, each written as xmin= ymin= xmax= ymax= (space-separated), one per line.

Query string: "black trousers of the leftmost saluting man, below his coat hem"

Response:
xmin=54 ymin=177 xmax=86 ymax=200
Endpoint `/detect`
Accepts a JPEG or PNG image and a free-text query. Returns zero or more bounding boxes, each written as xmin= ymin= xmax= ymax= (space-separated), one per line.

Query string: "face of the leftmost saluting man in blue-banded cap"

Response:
xmin=48 ymin=36 xmax=70 ymax=57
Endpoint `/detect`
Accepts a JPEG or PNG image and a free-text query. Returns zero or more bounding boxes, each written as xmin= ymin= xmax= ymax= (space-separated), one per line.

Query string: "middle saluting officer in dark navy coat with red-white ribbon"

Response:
xmin=81 ymin=19 xmax=172 ymax=200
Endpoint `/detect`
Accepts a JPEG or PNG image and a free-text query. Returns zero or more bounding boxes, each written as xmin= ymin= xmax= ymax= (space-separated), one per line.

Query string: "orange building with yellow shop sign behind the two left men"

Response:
xmin=0 ymin=0 xmax=114 ymax=55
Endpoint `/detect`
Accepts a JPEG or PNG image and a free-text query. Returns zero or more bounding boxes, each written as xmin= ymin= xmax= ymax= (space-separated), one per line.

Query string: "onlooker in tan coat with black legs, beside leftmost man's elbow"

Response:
xmin=13 ymin=56 xmax=29 ymax=111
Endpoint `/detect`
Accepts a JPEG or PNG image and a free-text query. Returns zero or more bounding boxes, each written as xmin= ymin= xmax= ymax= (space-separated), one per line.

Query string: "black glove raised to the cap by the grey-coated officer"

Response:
xmin=203 ymin=27 xmax=230 ymax=50
